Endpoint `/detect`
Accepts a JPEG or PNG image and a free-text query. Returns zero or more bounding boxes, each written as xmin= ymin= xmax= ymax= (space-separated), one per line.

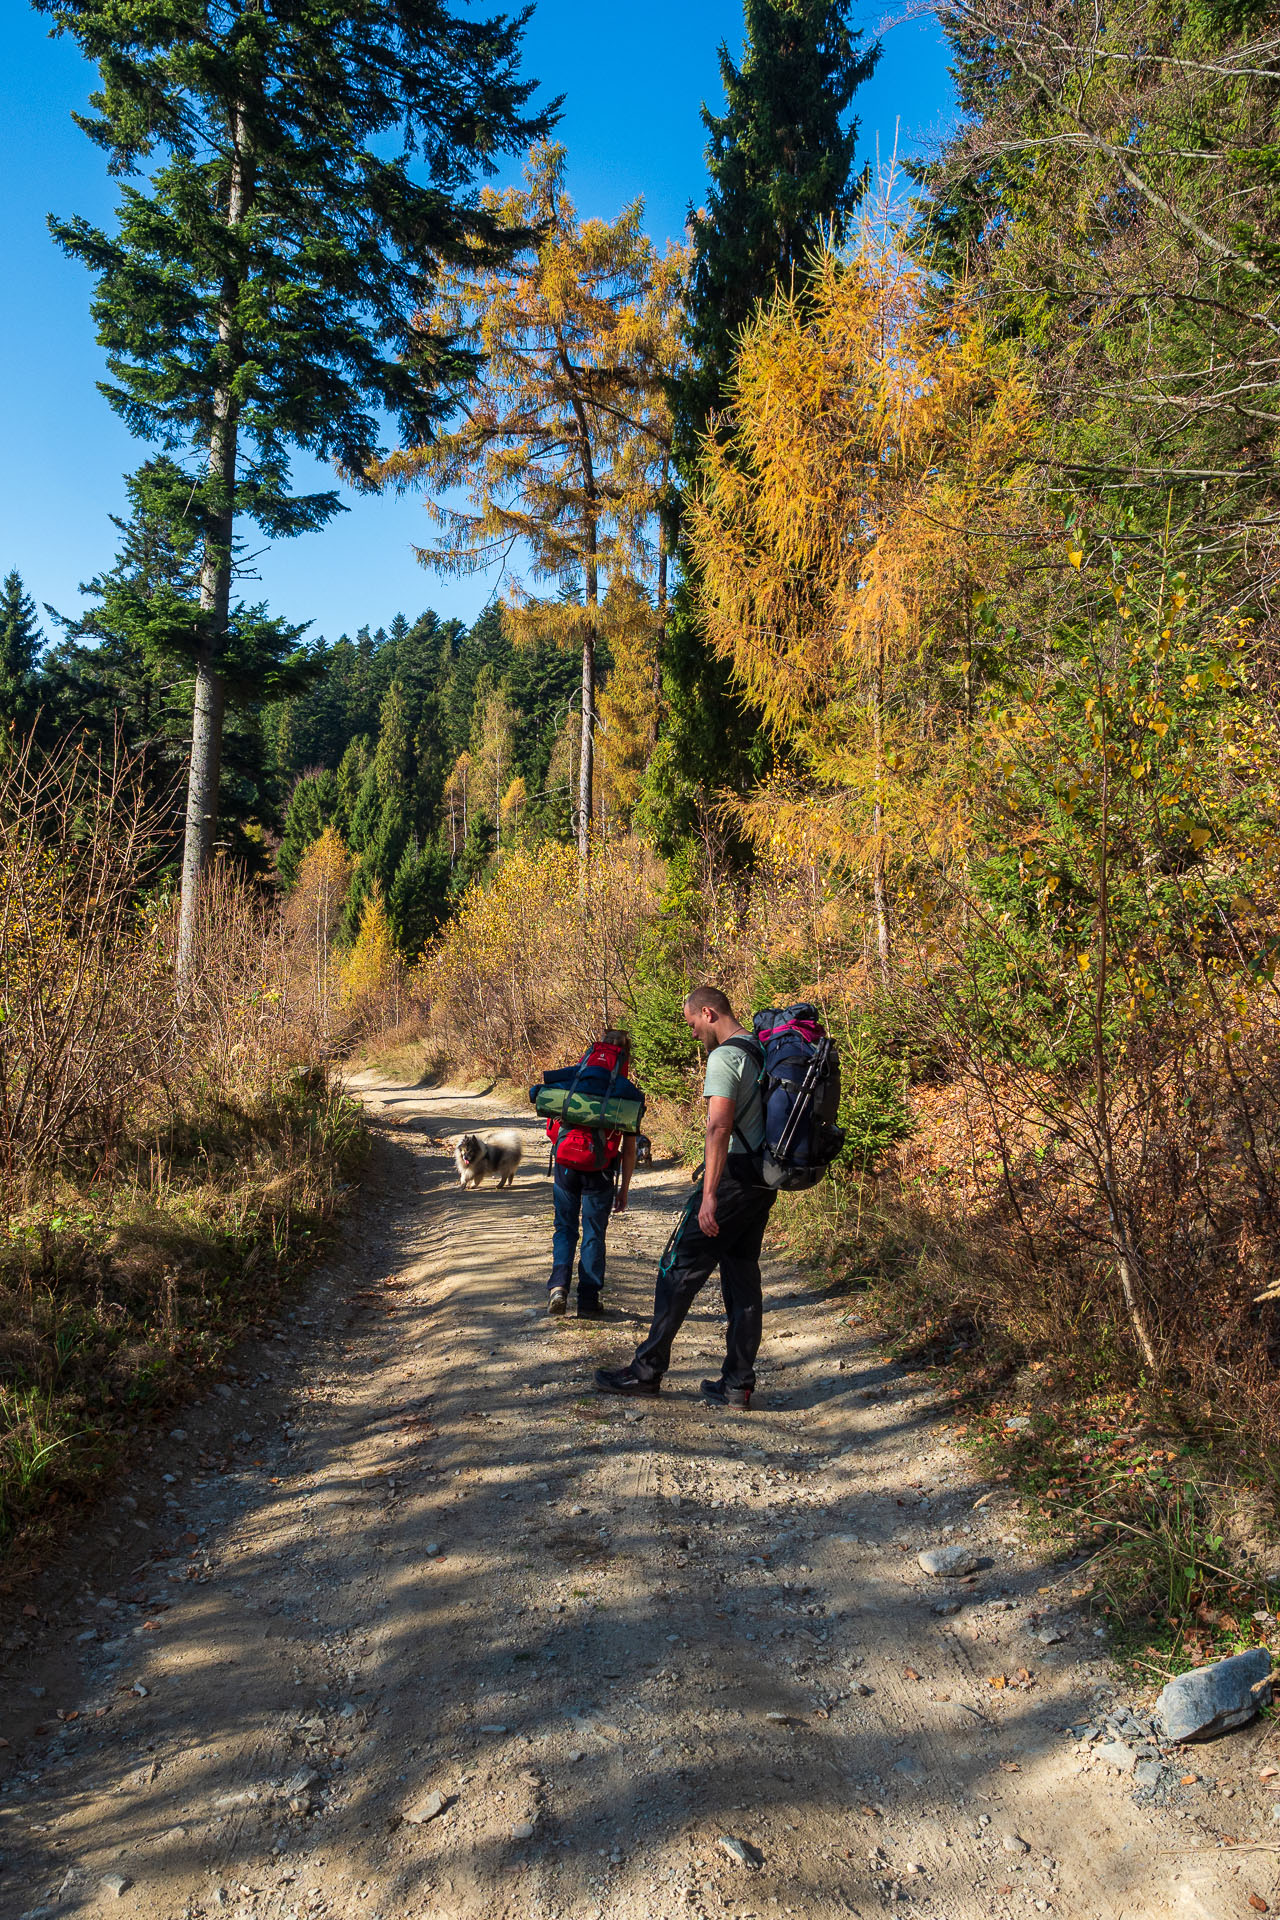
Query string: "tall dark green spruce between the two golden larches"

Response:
xmin=660 ymin=0 xmax=881 ymax=843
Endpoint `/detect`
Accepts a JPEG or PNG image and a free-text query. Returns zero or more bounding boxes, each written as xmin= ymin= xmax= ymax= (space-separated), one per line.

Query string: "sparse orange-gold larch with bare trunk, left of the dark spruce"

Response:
xmin=372 ymin=144 xmax=685 ymax=860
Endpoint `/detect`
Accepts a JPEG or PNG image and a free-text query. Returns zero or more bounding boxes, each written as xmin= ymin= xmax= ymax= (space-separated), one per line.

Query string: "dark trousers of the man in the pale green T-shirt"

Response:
xmin=631 ymin=1158 xmax=777 ymax=1386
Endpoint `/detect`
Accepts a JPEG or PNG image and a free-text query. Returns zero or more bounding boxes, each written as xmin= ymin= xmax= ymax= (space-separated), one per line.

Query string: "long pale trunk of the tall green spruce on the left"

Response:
xmin=177 ymin=109 xmax=253 ymax=987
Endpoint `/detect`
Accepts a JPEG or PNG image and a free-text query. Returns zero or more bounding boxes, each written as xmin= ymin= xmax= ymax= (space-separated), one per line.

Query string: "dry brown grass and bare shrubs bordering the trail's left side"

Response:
xmin=0 ymin=733 xmax=363 ymax=1549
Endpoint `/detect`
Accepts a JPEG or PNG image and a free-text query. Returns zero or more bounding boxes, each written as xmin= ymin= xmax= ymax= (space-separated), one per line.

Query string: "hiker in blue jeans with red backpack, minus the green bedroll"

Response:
xmin=547 ymin=1027 xmax=635 ymax=1319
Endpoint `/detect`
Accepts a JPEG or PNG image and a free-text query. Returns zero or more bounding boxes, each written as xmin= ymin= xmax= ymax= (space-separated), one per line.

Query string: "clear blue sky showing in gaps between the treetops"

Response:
xmin=0 ymin=0 xmax=952 ymax=639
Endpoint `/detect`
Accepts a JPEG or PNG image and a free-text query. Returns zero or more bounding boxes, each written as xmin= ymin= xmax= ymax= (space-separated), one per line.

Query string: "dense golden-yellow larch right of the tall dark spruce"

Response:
xmin=689 ymin=227 xmax=1034 ymax=975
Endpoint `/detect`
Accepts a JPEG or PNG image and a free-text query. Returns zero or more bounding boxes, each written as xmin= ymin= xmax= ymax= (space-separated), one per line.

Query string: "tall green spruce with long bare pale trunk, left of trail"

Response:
xmin=36 ymin=0 xmax=551 ymax=972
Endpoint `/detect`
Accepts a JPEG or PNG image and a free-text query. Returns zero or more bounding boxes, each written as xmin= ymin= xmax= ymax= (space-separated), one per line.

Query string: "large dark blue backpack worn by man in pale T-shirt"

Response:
xmin=723 ymin=1000 xmax=844 ymax=1192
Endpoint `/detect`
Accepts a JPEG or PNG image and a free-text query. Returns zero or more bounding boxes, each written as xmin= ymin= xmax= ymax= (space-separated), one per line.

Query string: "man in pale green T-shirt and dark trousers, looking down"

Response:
xmin=595 ymin=987 xmax=777 ymax=1407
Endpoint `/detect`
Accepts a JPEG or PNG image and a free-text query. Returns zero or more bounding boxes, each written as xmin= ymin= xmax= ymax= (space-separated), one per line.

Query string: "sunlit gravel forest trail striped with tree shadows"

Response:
xmin=0 ymin=1075 xmax=1276 ymax=1920
